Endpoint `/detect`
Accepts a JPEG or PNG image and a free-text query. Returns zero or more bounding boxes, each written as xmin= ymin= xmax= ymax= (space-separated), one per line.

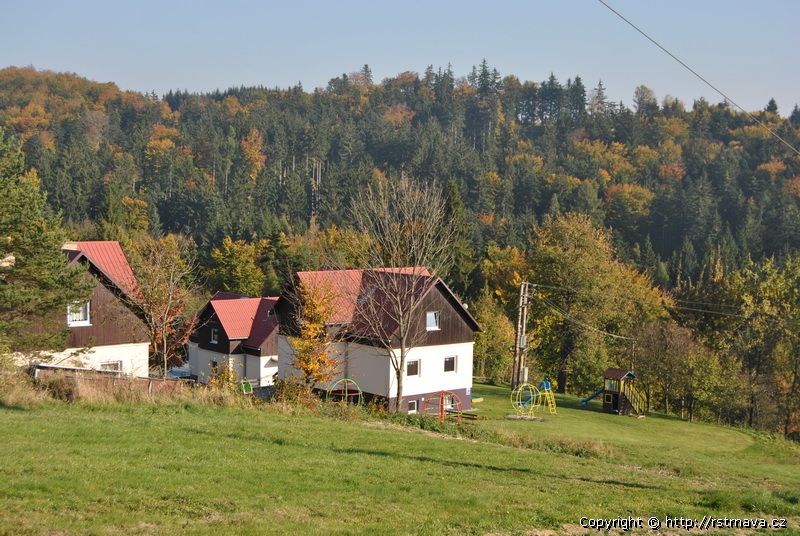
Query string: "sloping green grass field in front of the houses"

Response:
xmin=0 ymin=386 xmax=800 ymax=534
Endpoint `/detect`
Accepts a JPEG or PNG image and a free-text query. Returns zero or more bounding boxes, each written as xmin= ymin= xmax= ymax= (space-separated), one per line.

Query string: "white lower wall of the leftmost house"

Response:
xmin=47 ymin=342 xmax=150 ymax=378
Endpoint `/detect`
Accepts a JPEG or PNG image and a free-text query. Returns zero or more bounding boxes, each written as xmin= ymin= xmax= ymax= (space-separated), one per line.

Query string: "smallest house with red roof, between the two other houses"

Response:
xmin=188 ymin=292 xmax=278 ymax=387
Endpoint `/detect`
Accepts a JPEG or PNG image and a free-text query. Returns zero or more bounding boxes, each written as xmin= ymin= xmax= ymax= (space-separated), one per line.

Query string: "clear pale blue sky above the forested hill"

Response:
xmin=0 ymin=0 xmax=800 ymax=114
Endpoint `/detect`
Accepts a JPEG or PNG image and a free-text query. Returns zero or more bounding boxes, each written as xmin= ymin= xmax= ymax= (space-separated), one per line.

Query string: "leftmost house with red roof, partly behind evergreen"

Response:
xmin=47 ymin=241 xmax=150 ymax=376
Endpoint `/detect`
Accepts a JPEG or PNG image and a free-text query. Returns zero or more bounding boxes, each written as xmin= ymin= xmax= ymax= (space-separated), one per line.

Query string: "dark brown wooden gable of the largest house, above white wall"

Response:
xmin=394 ymin=285 xmax=474 ymax=346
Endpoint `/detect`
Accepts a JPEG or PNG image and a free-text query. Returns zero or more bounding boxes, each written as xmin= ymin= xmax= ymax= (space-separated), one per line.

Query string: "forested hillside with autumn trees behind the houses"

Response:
xmin=0 ymin=66 xmax=800 ymax=434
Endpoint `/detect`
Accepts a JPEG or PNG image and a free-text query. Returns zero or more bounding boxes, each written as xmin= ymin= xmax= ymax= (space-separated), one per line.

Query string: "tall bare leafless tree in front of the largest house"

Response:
xmin=338 ymin=176 xmax=454 ymax=411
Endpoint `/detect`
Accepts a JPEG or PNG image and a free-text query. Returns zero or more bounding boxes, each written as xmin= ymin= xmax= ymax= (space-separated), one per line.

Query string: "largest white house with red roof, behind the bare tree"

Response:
xmin=276 ymin=268 xmax=480 ymax=413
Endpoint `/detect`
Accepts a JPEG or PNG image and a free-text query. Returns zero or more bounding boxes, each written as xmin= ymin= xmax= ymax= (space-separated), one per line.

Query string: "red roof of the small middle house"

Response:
xmin=209 ymin=292 xmax=278 ymax=342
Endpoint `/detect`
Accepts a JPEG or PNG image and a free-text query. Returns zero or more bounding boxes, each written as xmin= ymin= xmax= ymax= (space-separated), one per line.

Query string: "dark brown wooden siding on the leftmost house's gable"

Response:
xmin=66 ymin=275 xmax=150 ymax=348
